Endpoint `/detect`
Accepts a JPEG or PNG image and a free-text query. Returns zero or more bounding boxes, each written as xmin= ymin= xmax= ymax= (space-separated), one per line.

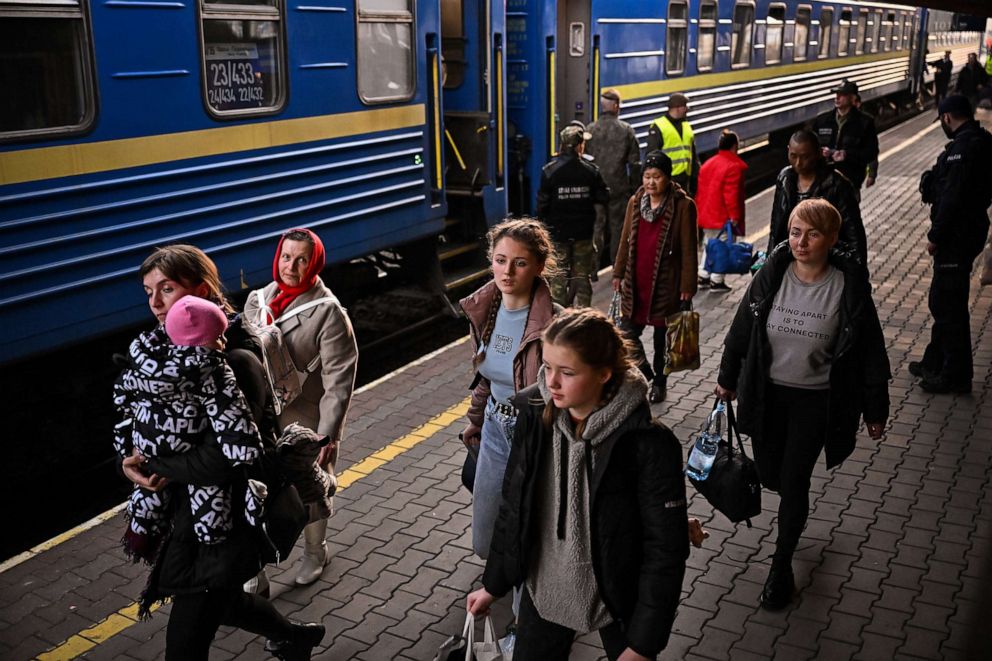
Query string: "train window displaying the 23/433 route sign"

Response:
xmin=200 ymin=0 xmax=286 ymax=117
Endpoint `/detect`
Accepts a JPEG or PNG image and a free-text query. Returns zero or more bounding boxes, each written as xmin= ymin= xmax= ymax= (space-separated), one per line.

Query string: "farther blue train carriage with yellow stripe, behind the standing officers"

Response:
xmin=507 ymin=0 xmax=926 ymax=214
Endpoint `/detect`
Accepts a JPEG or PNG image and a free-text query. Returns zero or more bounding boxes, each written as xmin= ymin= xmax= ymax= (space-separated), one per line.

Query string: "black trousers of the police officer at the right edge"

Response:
xmin=923 ymin=265 xmax=975 ymax=383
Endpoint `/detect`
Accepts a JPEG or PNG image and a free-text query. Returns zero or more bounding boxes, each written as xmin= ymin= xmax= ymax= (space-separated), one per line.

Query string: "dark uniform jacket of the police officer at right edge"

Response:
xmin=927 ymin=120 xmax=992 ymax=271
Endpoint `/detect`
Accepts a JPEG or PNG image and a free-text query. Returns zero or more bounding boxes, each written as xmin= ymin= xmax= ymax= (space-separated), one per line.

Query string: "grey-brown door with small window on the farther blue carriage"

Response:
xmin=554 ymin=0 xmax=593 ymax=131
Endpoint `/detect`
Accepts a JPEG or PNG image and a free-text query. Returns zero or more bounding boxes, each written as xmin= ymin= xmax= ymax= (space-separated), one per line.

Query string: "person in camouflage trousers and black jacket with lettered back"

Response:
xmin=537 ymin=126 xmax=610 ymax=307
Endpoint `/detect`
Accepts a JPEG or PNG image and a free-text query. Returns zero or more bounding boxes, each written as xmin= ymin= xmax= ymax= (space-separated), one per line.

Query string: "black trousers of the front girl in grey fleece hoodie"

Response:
xmin=513 ymin=588 xmax=640 ymax=661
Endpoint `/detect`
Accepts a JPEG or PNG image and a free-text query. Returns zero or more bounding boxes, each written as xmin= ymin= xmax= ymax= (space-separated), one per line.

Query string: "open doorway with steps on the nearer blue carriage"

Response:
xmin=438 ymin=0 xmax=507 ymax=290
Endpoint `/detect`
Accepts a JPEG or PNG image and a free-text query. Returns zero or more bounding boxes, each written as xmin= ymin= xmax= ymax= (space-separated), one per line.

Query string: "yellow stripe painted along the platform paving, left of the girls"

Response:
xmin=35 ymin=397 xmax=471 ymax=661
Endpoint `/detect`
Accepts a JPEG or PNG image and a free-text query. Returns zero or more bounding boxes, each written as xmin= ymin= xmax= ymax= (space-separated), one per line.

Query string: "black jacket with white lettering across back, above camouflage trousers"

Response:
xmin=537 ymin=151 xmax=610 ymax=242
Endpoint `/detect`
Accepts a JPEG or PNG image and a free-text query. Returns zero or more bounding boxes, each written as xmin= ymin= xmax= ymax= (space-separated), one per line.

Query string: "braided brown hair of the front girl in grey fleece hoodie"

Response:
xmin=541 ymin=308 xmax=634 ymax=438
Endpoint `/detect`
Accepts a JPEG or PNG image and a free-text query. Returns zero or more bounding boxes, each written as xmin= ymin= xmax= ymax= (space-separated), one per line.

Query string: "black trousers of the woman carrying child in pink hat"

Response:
xmin=165 ymin=588 xmax=293 ymax=661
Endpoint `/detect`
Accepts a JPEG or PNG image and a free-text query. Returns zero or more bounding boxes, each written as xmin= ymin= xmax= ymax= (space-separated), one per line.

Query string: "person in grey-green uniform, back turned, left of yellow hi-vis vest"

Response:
xmin=586 ymin=89 xmax=641 ymax=266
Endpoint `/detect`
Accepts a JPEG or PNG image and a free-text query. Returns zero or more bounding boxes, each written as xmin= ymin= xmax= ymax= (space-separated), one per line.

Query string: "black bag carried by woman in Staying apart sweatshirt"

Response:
xmin=689 ymin=401 xmax=761 ymax=528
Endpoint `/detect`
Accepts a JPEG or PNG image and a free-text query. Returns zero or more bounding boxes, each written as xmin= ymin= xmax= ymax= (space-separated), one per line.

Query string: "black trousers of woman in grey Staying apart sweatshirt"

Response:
xmin=754 ymin=384 xmax=830 ymax=561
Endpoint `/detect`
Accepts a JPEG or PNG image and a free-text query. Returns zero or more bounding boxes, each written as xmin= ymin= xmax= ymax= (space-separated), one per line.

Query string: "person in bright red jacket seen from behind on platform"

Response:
xmin=696 ymin=129 xmax=747 ymax=292
